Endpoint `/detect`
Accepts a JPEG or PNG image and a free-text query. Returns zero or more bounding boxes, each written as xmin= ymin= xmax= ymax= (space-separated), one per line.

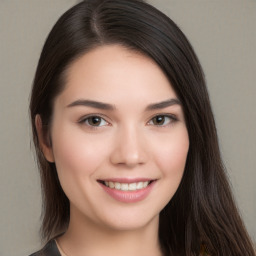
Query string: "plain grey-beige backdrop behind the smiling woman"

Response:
xmin=0 ymin=0 xmax=256 ymax=256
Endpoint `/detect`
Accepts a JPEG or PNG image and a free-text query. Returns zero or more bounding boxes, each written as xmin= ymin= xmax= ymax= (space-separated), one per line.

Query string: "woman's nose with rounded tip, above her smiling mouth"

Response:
xmin=110 ymin=126 xmax=147 ymax=168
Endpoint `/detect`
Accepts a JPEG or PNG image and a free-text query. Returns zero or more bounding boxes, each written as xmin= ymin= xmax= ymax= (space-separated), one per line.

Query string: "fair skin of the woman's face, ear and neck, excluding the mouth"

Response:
xmin=36 ymin=45 xmax=189 ymax=256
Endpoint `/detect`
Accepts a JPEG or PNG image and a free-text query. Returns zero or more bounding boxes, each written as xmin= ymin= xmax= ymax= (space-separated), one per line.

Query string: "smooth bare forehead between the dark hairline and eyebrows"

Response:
xmin=56 ymin=45 xmax=176 ymax=104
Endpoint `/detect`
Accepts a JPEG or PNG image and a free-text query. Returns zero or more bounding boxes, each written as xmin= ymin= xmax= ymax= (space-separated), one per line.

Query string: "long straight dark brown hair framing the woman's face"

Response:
xmin=30 ymin=0 xmax=255 ymax=256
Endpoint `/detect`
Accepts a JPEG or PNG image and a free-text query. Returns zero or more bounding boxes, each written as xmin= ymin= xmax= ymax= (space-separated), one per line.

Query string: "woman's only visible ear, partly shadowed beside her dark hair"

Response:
xmin=35 ymin=114 xmax=54 ymax=163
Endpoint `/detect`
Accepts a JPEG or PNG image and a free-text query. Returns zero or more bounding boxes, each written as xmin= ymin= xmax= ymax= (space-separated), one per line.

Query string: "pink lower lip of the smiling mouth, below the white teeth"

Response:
xmin=100 ymin=181 xmax=155 ymax=203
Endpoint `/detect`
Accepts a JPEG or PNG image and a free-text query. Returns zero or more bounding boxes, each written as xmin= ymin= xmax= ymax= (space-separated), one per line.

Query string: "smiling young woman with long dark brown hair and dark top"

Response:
xmin=30 ymin=0 xmax=255 ymax=256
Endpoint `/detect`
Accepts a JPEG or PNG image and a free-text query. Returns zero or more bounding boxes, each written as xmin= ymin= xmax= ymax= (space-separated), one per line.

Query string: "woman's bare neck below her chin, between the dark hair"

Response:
xmin=58 ymin=206 xmax=162 ymax=256
